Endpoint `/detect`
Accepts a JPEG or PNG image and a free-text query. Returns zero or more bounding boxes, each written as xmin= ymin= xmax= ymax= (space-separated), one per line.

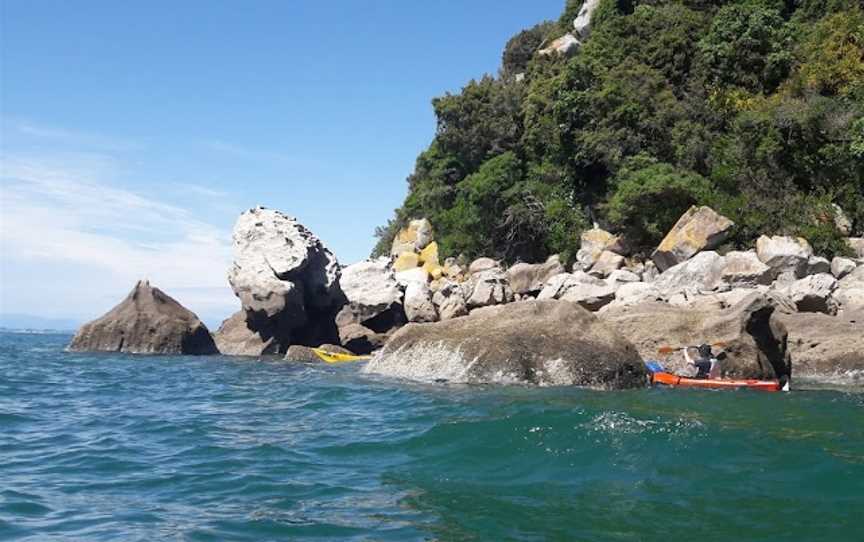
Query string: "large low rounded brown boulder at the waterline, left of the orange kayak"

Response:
xmin=364 ymin=300 xmax=646 ymax=388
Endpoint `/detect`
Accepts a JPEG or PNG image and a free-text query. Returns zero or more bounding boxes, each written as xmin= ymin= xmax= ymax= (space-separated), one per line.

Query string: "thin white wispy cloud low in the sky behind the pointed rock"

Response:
xmin=0 ymin=151 xmax=236 ymax=326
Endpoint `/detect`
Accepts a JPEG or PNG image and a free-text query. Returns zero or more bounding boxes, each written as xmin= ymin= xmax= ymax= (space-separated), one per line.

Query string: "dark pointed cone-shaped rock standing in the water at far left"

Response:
xmin=69 ymin=280 xmax=219 ymax=355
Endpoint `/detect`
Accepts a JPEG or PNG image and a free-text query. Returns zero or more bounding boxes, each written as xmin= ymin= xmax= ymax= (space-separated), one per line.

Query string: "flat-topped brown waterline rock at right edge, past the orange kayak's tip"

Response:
xmin=779 ymin=310 xmax=864 ymax=378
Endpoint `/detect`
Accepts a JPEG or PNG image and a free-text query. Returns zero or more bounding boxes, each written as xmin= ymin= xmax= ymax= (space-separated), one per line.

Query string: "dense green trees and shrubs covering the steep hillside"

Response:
xmin=375 ymin=0 xmax=864 ymax=261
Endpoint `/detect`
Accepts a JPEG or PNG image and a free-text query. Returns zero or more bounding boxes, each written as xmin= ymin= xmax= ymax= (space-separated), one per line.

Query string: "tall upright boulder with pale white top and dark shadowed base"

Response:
xmin=228 ymin=207 xmax=344 ymax=349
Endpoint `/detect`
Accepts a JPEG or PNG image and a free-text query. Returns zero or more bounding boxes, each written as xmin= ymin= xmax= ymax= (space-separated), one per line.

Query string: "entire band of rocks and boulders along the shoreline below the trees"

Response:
xmin=69 ymin=203 xmax=864 ymax=388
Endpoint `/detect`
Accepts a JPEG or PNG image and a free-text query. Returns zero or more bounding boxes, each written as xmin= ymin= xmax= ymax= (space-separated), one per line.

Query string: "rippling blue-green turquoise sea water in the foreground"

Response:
xmin=0 ymin=334 xmax=864 ymax=541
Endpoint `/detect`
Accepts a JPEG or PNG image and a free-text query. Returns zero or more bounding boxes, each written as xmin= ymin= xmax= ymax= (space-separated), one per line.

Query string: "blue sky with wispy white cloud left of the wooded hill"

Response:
xmin=0 ymin=0 xmax=564 ymax=326
